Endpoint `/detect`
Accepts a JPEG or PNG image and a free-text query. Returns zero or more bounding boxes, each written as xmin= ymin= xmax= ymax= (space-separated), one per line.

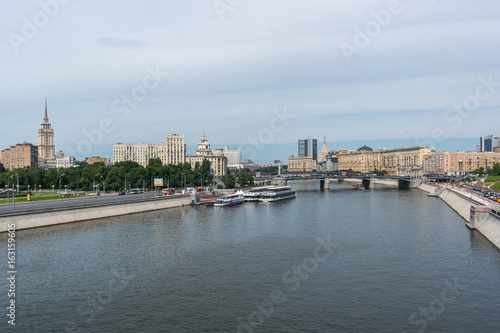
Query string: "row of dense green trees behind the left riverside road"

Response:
xmin=0 ymin=159 xmax=213 ymax=191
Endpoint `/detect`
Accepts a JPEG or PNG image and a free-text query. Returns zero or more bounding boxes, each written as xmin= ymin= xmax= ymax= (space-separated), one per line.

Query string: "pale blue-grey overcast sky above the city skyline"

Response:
xmin=0 ymin=0 xmax=500 ymax=162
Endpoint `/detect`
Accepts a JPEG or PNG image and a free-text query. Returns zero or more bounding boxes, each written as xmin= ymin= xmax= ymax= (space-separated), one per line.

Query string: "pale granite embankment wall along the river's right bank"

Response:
xmin=419 ymin=184 xmax=500 ymax=249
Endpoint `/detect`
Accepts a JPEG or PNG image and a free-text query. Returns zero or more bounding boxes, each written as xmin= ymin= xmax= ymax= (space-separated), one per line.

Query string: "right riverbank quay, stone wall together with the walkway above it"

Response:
xmin=419 ymin=184 xmax=500 ymax=249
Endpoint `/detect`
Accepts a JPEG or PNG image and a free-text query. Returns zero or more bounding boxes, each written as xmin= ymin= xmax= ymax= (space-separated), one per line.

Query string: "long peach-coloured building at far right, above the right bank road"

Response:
xmin=424 ymin=152 xmax=500 ymax=176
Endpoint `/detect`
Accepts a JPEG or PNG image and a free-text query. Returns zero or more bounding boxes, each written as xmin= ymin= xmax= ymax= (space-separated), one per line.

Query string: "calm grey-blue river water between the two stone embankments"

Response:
xmin=0 ymin=182 xmax=500 ymax=333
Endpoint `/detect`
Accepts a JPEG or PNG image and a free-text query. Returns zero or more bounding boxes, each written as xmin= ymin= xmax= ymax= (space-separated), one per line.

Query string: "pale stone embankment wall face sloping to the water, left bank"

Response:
xmin=0 ymin=196 xmax=192 ymax=232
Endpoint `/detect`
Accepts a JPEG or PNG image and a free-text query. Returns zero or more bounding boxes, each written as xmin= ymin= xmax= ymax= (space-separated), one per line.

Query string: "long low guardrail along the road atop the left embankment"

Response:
xmin=0 ymin=194 xmax=189 ymax=217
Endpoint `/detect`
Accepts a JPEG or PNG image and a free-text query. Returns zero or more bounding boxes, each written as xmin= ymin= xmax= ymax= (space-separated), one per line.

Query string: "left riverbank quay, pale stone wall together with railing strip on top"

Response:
xmin=0 ymin=194 xmax=193 ymax=232
